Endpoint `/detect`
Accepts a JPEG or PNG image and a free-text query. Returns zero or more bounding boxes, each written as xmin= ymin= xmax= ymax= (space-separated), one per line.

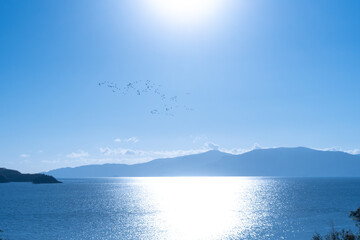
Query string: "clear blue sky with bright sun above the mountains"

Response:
xmin=0 ymin=0 xmax=360 ymax=172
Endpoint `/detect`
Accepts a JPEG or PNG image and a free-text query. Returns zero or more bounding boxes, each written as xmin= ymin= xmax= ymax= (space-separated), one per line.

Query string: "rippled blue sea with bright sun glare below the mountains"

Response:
xmin=0 ymin=177 xmax=360 ymax=240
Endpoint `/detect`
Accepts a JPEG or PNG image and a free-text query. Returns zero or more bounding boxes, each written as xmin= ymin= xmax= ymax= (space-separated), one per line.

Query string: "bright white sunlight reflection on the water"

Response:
xmin=129 ymin=177 xmax=282 ymax=240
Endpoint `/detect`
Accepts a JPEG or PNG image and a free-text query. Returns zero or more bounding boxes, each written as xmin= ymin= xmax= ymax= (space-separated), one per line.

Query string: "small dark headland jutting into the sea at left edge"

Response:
xmin=0 ymin=168 xmax=61 ymax=184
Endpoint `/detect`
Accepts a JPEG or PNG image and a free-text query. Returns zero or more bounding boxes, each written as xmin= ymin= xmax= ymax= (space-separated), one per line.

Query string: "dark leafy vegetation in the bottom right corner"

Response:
xmin=312 ymin=207 xmax=360 ymax=240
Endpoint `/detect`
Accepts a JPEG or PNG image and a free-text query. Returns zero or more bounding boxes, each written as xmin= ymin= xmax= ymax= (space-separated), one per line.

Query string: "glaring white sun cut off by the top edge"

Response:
xmin=146 ymin=0 xmax=224 ymax=26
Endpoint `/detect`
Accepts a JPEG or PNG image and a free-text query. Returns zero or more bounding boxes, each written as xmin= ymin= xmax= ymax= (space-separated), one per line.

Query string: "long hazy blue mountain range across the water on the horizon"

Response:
xmin=48 ymin=147 xmax=360 ymax=178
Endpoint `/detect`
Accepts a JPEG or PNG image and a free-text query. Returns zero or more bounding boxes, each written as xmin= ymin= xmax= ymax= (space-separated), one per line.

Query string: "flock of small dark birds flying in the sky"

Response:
xmin=99 ymin=80 xmax=193 ymax=116
